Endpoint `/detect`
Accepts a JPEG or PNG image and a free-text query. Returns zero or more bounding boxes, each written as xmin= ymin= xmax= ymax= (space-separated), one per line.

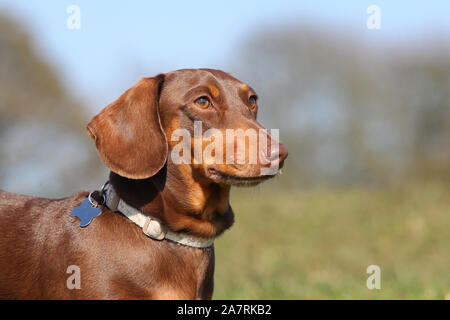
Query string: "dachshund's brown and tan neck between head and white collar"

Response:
xmin=110 ymin=163 xmax=234 ymax=238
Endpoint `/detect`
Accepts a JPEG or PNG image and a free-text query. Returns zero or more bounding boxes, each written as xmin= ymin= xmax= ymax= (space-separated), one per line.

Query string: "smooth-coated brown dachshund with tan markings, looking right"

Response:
xmin=0 ymin=69 xmax=287 ymax=299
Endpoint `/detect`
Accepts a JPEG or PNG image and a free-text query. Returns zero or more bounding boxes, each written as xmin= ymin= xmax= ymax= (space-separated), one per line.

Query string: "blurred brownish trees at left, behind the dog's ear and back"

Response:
xmin=0 ymin=15 xmax=106 ymax=196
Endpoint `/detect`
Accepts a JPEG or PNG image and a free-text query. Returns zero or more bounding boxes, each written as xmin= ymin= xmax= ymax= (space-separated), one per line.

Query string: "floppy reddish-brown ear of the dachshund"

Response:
xmin=87 ymin=74 xmax=168 ymax=179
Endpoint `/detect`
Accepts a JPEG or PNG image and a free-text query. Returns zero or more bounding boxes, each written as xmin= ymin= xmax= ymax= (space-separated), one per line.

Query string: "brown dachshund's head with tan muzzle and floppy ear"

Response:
xmin=87 ymin=69 xmax=287 ymax=185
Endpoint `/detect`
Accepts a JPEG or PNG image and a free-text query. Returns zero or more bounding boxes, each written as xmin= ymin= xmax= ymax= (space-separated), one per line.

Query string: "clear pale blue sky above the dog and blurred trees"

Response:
xmin=0 ymin=0 xmax=450 ymax=111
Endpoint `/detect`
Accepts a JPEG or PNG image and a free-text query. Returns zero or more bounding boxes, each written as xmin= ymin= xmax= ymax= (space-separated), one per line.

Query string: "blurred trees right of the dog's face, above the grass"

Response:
xmin=234 ymin=26 xmax=450 ymax=186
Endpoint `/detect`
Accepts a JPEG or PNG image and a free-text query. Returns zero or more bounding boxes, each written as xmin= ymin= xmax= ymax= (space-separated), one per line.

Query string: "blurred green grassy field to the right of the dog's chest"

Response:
xmin=214 ymin=183 xmax=450 ymax=299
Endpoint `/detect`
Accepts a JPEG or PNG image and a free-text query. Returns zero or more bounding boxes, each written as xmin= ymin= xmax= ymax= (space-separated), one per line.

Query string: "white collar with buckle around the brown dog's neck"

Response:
xmin=105 ymin=184 xmax=214 ymax=248
